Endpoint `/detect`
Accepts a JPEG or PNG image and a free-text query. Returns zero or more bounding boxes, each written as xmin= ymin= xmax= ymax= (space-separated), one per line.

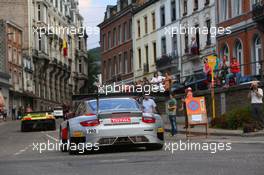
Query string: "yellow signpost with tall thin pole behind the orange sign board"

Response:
xmin=207 ymin=55 xmax=216 ymax=119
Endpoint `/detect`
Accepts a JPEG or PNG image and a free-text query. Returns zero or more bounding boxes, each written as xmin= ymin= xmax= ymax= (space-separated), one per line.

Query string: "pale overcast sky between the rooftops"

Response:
xmin=79 ymin=0 xmax=116 ymax=49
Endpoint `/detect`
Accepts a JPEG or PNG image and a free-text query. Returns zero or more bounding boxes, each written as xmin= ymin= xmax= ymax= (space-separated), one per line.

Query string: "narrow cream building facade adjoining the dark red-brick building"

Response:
xmin=132 ymin=0 xmax=158 ymax=81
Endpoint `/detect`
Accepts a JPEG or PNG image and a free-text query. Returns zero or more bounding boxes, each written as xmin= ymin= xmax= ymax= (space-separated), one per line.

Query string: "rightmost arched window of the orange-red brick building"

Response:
xmin=251 ymin=35 xmax=262 ymax=75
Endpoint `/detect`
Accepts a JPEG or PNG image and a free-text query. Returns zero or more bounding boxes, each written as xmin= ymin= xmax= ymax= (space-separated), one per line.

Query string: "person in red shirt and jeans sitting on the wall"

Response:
xmin=226 ymin=58 xmax=241 ymax=86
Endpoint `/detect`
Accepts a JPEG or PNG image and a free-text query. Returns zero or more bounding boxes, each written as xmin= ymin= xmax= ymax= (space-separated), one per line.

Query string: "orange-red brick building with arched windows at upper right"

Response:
xmin=216 ymin=0 xmax=264 ymax=75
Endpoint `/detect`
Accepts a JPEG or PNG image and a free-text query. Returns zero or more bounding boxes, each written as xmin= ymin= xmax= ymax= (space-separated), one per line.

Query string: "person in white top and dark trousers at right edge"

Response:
xmin=248 ymin=81 xmax=264 ymax=129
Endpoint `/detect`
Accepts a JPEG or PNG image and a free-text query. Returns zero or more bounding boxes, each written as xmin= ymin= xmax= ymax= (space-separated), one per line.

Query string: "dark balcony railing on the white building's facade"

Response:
xmin=156 ymin=53 xmax=179 ymax=70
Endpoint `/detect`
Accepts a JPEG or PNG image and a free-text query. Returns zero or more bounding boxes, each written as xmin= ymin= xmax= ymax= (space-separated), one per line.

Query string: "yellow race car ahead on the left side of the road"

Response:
xmin=21 ymin=111 xmax=56 ymax=132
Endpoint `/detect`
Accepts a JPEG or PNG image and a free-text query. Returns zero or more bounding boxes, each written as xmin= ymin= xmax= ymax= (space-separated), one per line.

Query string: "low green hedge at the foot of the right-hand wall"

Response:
xmin=211 ymin=106 xmax=254 ymax=129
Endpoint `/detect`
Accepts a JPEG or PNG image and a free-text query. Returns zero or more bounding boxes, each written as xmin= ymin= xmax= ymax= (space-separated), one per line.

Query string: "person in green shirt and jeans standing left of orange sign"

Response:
xmin=167 ymin=94 xmax=177 ymax=136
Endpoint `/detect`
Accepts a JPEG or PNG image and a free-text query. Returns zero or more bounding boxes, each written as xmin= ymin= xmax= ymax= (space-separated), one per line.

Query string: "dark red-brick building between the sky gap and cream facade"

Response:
xmin=98 ymin=0 xmax=136 ymax=84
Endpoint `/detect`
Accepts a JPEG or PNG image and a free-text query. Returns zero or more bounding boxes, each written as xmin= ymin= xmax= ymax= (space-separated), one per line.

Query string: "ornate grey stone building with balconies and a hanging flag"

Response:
xmin=0 ymin=0 xmax=88 ymax=110
